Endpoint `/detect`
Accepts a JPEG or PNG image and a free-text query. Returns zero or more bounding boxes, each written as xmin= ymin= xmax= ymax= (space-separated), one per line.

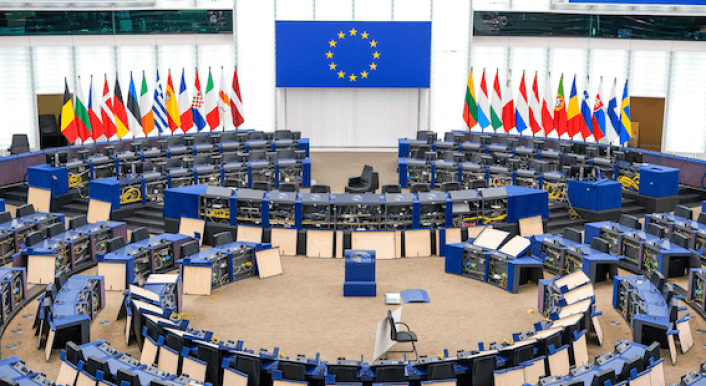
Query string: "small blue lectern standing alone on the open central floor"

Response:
xmin=343 ymin=250 xmax=377 ymax=297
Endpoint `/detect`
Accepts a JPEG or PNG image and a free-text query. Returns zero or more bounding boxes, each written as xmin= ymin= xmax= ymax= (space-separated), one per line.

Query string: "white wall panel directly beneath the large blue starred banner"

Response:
xmin=285 ymin=88 xmax=419 ymax=147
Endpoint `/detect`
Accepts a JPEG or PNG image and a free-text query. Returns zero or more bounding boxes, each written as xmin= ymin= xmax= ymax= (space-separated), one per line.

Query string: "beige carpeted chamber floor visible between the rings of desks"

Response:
xmin=0 ymin=153 xmax=706 ymax=383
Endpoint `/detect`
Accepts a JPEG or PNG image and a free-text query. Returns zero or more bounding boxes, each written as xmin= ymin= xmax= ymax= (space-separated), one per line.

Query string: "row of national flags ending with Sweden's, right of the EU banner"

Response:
xmin=463 ymin=68 xmax=633 ymax=144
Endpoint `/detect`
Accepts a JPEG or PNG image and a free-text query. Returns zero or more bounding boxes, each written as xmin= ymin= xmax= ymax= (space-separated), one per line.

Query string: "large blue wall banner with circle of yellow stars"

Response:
xmin=275 ymin=21 xmax=431 ymax=88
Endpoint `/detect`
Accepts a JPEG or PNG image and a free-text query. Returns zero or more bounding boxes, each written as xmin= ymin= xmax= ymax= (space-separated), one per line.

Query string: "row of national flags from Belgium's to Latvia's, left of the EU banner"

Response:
xmin=61 ymin=68 xmax=245 ymax=143
